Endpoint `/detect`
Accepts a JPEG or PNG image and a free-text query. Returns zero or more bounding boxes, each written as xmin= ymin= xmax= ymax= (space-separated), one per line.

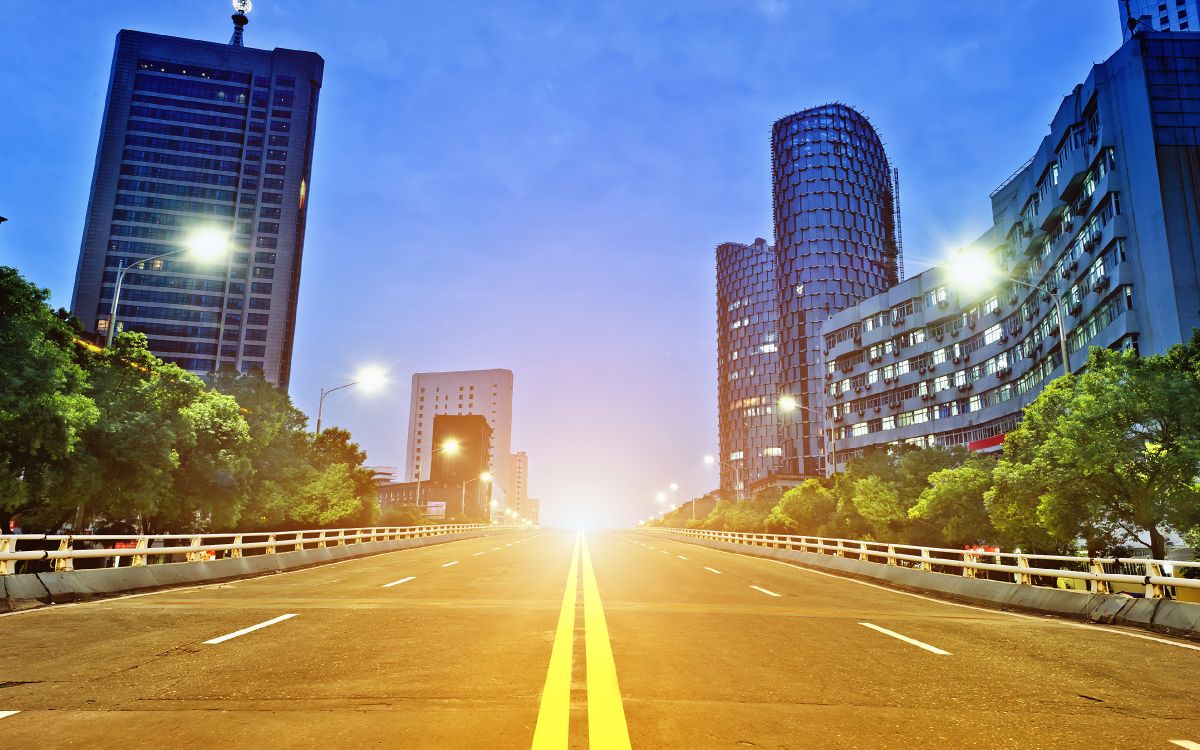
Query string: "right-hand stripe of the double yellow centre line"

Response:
xmin=583 ymin=539 xmax=631 ymax=750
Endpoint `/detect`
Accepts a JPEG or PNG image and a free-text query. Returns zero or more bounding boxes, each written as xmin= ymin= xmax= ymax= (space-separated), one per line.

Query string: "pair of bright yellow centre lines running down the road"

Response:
xmin=533 ymin=534 xmax=630 ymax=750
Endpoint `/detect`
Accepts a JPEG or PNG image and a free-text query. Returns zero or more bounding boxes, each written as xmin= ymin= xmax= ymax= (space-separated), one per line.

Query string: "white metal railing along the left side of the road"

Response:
xmin=0 ymin=523 xmax=498 ymax=576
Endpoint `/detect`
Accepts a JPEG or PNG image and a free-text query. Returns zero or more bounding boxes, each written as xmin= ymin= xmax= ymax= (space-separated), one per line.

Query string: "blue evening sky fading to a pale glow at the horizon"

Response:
xmin=0 ymin=0 xmax=1121 ymax=524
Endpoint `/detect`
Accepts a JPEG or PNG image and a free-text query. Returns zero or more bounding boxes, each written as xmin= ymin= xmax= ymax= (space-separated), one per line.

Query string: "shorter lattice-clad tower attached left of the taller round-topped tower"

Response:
xmin=716 ymin=238 xmax=784 ymax=493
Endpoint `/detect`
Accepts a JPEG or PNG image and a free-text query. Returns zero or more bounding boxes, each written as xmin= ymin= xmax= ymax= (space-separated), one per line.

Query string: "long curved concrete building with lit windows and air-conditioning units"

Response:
xmin=822 ymin=31 xmax=1200 ymax=468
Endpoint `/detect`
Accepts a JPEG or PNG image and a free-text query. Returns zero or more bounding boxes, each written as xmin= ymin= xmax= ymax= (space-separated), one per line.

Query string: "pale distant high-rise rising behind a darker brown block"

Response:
xmin=404 ymin=370 xmax=512 ymax=512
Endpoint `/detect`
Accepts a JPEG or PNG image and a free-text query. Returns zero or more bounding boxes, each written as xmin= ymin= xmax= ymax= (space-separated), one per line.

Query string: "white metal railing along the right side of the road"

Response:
xmin=646 ymin=527 xmax=1200 ymax=599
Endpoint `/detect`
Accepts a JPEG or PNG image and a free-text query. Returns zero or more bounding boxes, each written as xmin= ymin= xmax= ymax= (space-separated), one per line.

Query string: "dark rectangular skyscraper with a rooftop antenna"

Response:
xmin=72 ymin=12 xmax=324 ymax=386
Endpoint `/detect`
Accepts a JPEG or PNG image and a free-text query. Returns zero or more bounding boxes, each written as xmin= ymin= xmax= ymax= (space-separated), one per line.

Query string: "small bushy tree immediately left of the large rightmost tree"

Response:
xmin=908 ymin=458 xmax=997 ymax=547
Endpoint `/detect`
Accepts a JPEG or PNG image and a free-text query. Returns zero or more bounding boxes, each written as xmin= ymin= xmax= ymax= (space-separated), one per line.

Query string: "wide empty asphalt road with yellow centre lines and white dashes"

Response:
xmin=0 ymin=530 xmax=1200 ymax=750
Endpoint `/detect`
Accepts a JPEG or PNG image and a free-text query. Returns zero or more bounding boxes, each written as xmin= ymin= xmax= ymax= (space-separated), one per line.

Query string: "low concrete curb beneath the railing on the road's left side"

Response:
xmin=0 ymin=529 xmax=510 ymax=611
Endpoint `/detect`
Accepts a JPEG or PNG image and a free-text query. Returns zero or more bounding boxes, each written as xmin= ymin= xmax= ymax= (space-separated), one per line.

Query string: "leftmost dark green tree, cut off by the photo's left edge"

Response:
xmin=0 ymin=266 xmax=100 ymax=533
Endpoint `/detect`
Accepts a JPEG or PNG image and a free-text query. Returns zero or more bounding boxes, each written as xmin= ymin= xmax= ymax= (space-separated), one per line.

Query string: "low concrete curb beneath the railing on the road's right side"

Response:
xmin=650 ymin=533 xmax=1200 ymax=640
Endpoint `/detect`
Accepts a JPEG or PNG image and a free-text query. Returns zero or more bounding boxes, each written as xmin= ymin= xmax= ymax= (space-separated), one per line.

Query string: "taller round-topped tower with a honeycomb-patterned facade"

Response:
xmin=770 ymin=103 xmax=901 ymax=476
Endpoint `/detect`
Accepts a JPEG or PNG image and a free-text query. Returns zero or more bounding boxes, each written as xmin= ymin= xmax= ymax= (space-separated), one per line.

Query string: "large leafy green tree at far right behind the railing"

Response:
xmin=988 ymin=336 xmax=1200 ymax=558
